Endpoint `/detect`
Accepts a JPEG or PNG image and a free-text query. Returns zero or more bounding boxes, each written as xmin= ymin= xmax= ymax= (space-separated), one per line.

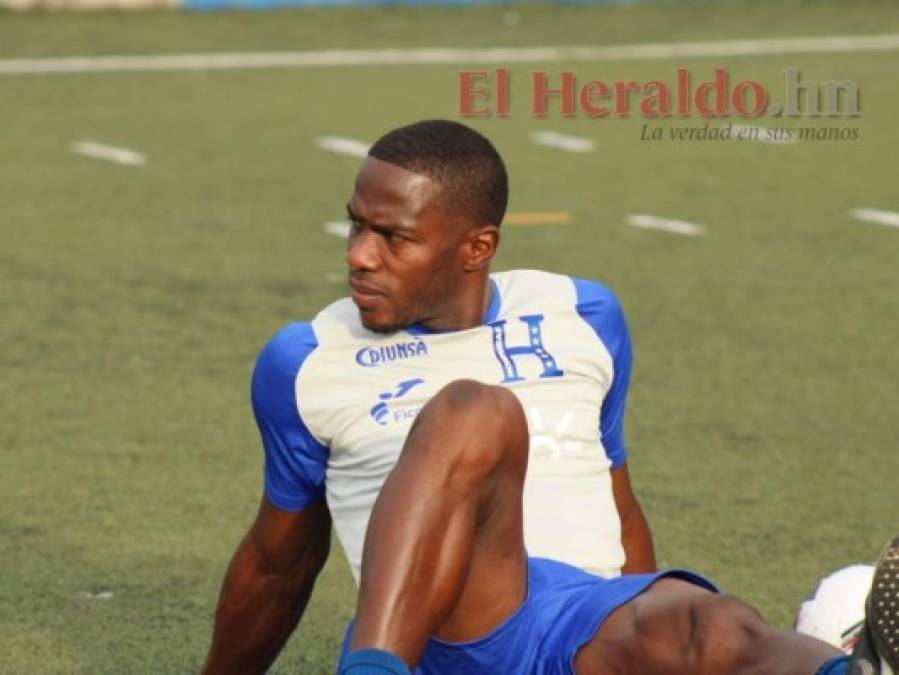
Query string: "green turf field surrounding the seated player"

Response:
xmin=0 ymin=2 xmax=899 ymax=675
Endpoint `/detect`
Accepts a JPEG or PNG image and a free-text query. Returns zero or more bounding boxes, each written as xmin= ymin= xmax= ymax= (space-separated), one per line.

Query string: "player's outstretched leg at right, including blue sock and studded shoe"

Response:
xmin=575 ymin=537 xmax=899 ymax=675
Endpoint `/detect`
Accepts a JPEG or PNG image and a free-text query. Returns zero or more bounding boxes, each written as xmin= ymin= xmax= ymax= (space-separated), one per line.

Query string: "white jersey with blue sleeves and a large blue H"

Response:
xmin=252 ymin=270 xmax=631 ymax=582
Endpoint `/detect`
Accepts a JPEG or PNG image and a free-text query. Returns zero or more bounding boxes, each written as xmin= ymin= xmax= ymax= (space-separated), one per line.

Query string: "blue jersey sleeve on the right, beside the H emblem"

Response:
xmin=573 ymin=279 xmax=631 ymax=468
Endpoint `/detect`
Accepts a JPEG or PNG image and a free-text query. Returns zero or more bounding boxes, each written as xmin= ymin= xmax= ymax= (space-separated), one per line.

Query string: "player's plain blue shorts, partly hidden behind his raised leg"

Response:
xmin=341 ymin=558 xmax=717 ymax=675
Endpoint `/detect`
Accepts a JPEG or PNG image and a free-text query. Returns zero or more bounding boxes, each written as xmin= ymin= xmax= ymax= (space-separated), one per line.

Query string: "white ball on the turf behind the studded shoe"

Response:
xmin=796 ymin=565 xmax=874 ymax=654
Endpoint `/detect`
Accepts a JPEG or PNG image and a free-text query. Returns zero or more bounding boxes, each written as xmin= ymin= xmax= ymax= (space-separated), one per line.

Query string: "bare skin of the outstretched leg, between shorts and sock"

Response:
xmin=575 ymin=579 xmax=841 ymax=675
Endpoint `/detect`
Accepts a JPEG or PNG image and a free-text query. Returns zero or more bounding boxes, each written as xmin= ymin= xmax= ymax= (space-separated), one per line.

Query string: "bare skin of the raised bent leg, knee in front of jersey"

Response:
xmin=351 ymin=381 xmax=528 ymax=665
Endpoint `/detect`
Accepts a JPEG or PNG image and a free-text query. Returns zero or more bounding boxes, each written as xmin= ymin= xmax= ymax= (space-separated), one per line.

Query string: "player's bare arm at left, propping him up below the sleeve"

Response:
xmin=203 ymin=497 xmax=331 ymax=675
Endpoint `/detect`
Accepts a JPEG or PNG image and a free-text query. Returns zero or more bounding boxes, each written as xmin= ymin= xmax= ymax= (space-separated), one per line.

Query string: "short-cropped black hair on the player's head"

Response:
xmin=368 ymin=120 xmax=509 ymax=227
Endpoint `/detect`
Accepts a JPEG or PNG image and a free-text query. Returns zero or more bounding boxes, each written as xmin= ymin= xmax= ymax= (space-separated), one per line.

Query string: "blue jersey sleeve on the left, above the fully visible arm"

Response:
xmin=251 ymin=323 xmax=328 ymax=511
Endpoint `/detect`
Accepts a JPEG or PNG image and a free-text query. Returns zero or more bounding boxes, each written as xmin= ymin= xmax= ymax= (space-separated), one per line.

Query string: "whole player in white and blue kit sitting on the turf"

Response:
xmin=204 ymin=121 xmax=899 ymax=675
